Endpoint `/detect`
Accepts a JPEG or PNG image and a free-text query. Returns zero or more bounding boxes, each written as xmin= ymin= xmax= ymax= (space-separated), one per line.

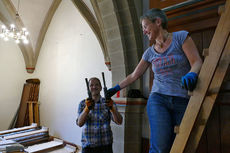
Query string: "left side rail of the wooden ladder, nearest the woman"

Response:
xmin=171 ymin=1 xmax=230 ymax=153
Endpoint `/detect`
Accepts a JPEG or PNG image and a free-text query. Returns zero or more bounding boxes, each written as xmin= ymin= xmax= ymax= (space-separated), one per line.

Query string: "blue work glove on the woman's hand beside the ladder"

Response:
xmin=181 ymin=72 xmax=198 ymax=91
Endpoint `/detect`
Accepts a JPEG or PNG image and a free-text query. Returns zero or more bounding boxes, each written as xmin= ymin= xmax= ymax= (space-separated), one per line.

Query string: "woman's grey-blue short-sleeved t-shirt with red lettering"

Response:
xmin=142 ymin=31 xmax=191 ymax=98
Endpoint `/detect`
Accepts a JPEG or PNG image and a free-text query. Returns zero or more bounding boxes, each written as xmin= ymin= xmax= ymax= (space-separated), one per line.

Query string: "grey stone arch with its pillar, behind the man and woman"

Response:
xmin=73 ymin=0 xmax=146 ymax=153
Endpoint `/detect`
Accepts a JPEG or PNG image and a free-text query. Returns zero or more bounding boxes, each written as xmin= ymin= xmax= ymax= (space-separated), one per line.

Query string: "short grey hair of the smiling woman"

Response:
xmin=140 ymin=8 xmax=168 ymax=29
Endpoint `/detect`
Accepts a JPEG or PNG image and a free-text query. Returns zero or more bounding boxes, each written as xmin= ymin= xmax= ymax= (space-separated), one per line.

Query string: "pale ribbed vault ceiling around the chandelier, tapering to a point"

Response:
xmin=0 ymin=0 xmax=94 ymax=73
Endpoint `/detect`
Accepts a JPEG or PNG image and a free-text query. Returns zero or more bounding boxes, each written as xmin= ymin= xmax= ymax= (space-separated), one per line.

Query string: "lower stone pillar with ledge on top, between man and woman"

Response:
xmin=111 ymin=98 xmax=146 ymax=153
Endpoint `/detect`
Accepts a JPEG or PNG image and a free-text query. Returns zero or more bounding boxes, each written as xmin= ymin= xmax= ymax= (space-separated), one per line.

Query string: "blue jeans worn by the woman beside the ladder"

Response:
xmin=147 ymin=93 xmax=189 ymax=153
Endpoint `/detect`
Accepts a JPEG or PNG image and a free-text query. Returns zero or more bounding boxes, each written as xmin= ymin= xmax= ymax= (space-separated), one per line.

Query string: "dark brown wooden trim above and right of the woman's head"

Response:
xmin=150 ymin=0 xmax=226 ymax=32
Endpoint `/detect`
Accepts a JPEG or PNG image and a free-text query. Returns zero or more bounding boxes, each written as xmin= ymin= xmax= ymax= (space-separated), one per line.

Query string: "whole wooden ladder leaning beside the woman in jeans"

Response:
xmin=170 ymin=0 xmax=230 ymax=153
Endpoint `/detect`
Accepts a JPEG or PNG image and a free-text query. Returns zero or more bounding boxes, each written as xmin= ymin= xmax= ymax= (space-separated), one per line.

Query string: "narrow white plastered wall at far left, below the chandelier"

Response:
xmin=0 ymin=39 xmax=29 ymax=130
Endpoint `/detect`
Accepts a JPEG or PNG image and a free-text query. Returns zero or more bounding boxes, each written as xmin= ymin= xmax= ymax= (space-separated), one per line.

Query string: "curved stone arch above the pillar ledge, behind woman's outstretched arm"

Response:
xmin=72 ymin=0 xmax=143 ymax=97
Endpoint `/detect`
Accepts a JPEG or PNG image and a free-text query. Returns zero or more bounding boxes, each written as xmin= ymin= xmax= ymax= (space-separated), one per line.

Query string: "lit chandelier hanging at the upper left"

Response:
xmin=0 ymin=0 xmax=29 ymax=44
